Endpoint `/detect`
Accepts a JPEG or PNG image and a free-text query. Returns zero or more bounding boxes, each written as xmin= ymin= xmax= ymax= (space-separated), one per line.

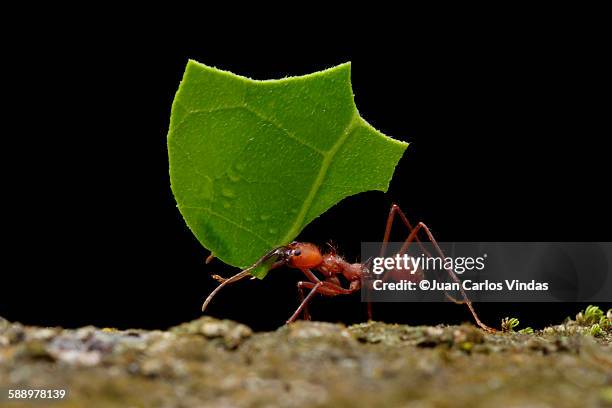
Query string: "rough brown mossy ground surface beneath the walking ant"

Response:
xmin=0 ymin=310 xmax=612 ymax=407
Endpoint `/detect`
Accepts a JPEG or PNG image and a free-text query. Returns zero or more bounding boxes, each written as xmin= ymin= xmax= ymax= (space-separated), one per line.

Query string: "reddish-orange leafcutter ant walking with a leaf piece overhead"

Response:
xmin=202 ymin=204 xmax=496 ymax=333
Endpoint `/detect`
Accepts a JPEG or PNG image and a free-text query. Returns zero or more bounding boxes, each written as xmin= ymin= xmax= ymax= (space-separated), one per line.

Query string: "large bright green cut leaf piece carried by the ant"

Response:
xmin=168 ymin=60 xmax=407 ymax=277
